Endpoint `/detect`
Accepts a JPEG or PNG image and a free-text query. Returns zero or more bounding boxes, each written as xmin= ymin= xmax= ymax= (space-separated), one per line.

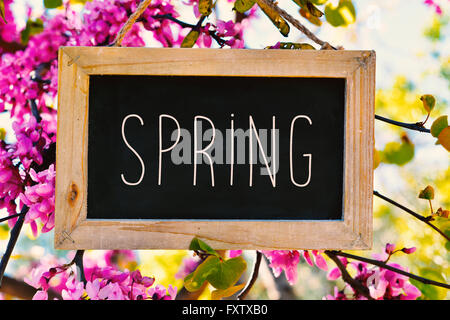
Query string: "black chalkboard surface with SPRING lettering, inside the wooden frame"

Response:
xmin=87 ymin=75 xmax=346 ymax=220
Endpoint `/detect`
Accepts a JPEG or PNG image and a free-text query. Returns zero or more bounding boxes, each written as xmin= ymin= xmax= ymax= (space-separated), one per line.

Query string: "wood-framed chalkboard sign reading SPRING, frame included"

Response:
xmin=55 ymin=47 xmax=375 ymax=250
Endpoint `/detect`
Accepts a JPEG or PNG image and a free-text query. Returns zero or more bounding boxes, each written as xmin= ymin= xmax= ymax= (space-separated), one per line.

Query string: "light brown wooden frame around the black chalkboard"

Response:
xmin=55 ymin=47 xmax=375 ymax=250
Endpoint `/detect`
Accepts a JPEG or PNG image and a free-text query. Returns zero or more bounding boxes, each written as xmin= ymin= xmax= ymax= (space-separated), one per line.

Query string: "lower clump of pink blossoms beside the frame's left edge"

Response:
xmin=0 ymin=116 xmax=55 ymax=236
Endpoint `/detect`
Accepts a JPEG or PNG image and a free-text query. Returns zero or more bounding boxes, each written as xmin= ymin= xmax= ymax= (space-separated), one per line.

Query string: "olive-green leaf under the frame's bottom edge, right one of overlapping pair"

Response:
xmin=208 ymin=257 xmax=247 ymax=290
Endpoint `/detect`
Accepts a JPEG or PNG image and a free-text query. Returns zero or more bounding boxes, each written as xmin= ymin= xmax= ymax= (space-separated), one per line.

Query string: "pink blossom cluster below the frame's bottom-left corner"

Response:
xmin=25 ymin=250 xmax=177 ymax=300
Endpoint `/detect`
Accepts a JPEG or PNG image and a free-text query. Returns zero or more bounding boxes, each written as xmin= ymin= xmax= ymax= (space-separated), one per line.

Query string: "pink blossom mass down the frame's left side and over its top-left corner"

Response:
xmin=0 ymin=0 xmax=181 ymax=235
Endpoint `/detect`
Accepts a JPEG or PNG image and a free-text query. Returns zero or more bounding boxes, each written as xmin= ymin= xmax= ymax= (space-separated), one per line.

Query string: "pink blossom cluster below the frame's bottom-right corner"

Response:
xmin=325 ymin=243 xmax=421 ymax=300
